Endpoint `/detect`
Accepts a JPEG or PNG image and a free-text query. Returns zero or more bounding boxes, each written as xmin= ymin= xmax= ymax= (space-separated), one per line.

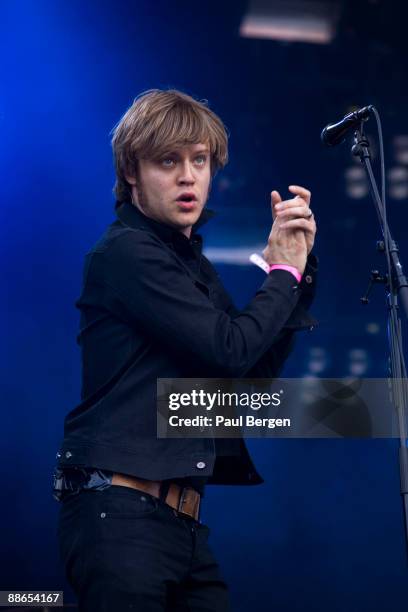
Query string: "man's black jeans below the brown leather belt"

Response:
xmin=58 ymin=486 xmax=230 ymax=612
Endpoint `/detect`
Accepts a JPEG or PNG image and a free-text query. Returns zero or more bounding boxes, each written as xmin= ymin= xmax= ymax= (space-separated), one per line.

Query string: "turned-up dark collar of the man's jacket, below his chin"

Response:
xmin=115 ymin=202 xmax=215 ymax=242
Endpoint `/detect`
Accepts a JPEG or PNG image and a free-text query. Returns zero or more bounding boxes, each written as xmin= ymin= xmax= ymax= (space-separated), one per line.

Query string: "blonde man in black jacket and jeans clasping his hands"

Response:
xmin=55 ymin=90 xmax=316 ymax=612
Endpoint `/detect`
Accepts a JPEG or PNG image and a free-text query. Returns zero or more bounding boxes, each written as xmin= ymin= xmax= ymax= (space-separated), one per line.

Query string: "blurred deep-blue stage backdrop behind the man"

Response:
xmin=0 ymin=0 xmax=408 ymax=612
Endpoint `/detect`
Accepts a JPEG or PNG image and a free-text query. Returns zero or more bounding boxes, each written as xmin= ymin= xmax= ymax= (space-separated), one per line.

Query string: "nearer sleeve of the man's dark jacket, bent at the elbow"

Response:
xmin=85 ymin=230 xmax=301 ymax=377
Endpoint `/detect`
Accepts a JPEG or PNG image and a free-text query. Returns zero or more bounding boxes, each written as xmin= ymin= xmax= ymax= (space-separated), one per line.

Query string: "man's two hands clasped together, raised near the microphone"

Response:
xmin=262 ymin=185 xmax=316 ymax=274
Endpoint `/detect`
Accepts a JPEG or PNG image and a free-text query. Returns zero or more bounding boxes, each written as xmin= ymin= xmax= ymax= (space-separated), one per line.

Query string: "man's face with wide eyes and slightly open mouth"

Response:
xmin=126 ymin=143 xmax=211 ymax=237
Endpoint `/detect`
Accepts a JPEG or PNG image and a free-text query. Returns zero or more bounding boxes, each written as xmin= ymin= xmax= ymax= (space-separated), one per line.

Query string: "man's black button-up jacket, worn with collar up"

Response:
xmin=57 ymin=203 xmax=317 ymax=484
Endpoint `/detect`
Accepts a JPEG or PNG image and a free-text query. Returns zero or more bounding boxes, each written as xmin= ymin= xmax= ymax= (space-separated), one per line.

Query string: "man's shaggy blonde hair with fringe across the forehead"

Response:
xmin=112 ymin=89 xmax=228 ymax=202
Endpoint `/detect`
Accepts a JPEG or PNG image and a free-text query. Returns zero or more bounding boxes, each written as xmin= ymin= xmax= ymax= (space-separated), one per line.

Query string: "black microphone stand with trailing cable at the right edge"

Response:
xmin=351 ymin=116 xmax=408 ymax=553
